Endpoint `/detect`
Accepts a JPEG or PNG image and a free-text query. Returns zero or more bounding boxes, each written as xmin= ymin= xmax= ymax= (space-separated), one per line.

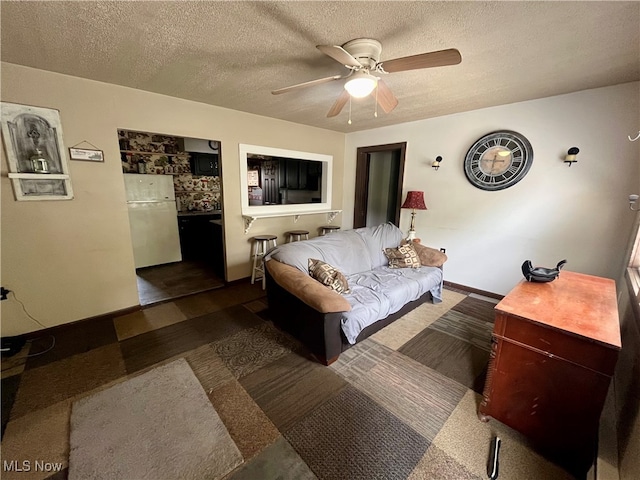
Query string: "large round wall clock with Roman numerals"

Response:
xmin=464 ymin=130 xmax=533 ymax=191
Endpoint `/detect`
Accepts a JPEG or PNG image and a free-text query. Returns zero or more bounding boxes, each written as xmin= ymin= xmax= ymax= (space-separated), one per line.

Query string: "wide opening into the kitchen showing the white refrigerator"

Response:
xmin=118 ymin=129 xmax=225 ymax=306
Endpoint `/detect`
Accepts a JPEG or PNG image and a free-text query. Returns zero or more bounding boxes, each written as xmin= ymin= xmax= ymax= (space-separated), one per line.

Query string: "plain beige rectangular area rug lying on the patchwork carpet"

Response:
xmin=69 ymin=358 xmax=243 ymax=480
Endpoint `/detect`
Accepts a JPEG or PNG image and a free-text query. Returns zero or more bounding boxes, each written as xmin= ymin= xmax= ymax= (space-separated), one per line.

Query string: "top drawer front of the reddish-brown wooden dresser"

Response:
xmin=494 ymin=311 xmax=618 ymax=376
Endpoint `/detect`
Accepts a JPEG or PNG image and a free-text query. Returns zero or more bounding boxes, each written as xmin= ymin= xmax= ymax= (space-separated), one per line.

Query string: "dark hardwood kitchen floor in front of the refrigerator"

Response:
xmin=136 ymin=260 xmax=225 ymax=305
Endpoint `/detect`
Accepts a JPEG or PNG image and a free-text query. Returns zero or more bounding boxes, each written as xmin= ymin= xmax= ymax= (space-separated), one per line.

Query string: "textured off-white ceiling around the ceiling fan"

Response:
xmin=0 ymin=1 xmax=640 ymax=132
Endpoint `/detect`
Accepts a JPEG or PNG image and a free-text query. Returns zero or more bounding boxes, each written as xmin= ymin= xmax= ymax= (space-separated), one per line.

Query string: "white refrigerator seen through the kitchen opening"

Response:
xmin=124 ymin=173 xmax=182 ymax=268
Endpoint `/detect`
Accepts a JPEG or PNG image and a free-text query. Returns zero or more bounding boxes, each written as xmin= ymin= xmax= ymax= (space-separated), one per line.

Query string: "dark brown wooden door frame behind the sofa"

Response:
xmin=353 ymin=142 xmax=407 ymax=228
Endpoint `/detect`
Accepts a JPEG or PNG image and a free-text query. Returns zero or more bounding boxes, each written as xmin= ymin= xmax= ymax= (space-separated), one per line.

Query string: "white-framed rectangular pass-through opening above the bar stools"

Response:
xmin=240 ymin=144 xmax=333 ymax=216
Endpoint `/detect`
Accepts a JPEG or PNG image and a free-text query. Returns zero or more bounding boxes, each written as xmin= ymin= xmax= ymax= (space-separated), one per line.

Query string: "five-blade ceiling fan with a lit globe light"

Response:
xmin=271 ymin=38 xmax=462 ymax=117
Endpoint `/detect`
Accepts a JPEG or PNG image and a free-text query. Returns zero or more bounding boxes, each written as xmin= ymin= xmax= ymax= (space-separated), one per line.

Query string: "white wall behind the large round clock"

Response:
xmin=343 ymin=82 xmax=640 ymax=294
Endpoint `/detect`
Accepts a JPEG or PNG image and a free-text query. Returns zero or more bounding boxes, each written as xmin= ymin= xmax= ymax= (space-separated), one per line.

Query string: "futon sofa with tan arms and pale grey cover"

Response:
xmin=265 ymin=223 xmax=446 ymax=365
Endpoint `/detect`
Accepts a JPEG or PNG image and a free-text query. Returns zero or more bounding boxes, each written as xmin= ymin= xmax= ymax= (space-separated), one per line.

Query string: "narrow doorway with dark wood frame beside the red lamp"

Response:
xmin=353 ymin=142 xmax=407 ymax=228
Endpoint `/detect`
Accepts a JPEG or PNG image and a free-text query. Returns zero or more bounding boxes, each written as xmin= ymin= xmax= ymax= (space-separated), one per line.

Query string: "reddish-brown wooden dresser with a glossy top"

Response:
xmin=479 ymin=270 xmax=621 ymax=470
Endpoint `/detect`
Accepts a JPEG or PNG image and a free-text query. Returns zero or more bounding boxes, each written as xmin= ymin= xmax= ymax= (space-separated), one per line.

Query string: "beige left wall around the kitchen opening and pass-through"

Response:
xmin=0 ymin=63 xmax=344 ymax=336
